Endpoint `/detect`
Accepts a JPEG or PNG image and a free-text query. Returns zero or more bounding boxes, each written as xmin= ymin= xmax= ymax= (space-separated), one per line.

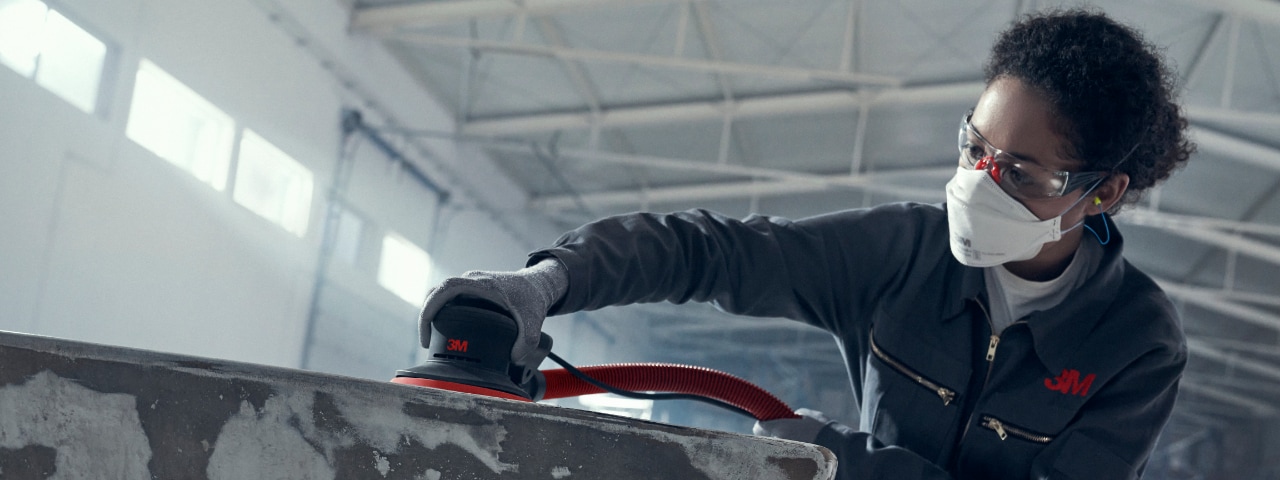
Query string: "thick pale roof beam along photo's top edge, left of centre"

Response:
xmin=351 ymin=0 xmax=681 ymax=31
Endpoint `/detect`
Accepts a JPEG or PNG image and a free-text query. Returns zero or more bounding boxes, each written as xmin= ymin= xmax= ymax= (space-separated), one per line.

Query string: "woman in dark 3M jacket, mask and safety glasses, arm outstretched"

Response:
xmin=422 ymin=10 xmax=1193 ymax=479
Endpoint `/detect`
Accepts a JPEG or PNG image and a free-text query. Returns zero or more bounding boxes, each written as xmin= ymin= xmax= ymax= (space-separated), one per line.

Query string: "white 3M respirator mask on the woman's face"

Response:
xmin=947 ymin=166 xmax=1097 ymax=266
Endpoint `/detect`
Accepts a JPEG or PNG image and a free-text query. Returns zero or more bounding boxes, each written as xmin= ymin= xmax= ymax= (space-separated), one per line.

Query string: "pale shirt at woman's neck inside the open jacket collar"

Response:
xmin=983 ymin=239 xmax=1102 ymax=335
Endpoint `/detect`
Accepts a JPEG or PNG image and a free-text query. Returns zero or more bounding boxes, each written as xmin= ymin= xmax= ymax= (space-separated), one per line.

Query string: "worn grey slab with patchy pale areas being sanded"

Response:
xmin=0 ymin=332 xmax=835 ymax=480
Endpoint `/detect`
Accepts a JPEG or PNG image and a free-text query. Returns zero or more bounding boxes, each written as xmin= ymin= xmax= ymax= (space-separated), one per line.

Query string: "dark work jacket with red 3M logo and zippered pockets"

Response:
xmin=530 ymin=204 xmax=1187 ymax=480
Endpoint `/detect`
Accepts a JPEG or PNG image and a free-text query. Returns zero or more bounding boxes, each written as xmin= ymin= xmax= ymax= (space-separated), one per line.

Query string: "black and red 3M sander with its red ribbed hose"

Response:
xmin=392 ymin=297 xmax=797 ymax=421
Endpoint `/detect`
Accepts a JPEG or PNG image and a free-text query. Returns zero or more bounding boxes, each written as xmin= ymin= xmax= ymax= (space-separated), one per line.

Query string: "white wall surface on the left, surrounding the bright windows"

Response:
xmin=0 ymin=0 xmax=542 ymax=375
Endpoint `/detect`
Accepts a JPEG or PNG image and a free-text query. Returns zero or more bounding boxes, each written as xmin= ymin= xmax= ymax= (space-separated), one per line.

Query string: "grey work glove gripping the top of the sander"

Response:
xmin=417 ymin=259 xmax=568 ymax=367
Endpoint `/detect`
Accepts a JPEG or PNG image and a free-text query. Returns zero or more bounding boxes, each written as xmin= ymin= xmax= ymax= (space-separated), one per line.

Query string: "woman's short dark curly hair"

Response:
xmin=984 ymin=9 xmax=1196 ymax=210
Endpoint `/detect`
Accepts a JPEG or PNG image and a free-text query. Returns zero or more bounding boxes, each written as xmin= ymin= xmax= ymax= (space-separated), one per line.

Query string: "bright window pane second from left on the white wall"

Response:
xmin=125 ymin=59 xmax=236 ymax=191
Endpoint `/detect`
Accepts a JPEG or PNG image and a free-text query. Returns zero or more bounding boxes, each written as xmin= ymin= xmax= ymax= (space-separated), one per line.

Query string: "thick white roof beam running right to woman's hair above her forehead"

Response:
xmin=460 ymin=82 xmax=986 ymax=136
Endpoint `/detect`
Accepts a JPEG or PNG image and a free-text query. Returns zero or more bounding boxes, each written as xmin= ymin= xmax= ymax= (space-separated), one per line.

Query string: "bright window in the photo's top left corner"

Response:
xmin=0 ymin=0 xmax=106 ymax=113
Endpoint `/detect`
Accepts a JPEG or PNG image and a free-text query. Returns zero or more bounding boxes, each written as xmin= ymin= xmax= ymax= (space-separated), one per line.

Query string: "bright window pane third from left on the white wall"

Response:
xmin=232 ymin=129 xmax=312 ymax=237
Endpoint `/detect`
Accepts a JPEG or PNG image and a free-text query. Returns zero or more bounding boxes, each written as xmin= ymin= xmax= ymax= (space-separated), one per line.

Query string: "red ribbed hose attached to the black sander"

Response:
xmin=541 ymin=364 xmax=797 ymax=421
